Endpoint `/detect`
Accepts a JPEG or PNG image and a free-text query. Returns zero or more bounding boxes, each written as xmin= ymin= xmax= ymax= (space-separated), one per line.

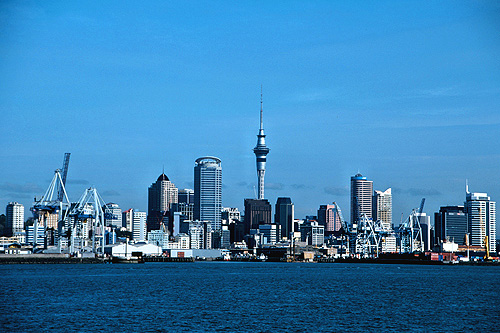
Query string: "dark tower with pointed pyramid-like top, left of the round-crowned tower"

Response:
xmin=147 ymin=173 xmax=178 ymax=231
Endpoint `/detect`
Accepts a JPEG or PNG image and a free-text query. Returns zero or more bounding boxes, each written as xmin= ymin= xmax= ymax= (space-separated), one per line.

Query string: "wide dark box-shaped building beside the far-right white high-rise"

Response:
xmin=434 ymin=206 xmax=467 ymax=245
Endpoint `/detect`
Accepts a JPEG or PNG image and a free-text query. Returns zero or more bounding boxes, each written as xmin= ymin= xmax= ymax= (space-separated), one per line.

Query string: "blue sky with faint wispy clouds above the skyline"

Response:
xmin=0 ymin=1 xmax=500 ymax=233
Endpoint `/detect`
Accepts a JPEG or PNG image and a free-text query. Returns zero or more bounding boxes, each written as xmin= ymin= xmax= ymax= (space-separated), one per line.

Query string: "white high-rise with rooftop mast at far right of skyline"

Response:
xmin=465 ymin=188 xmax=496 ymax=252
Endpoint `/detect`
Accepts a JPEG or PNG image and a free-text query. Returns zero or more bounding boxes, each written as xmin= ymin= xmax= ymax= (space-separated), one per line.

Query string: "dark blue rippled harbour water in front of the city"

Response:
xmin=0 ymin=262 xmax=500 ymax=332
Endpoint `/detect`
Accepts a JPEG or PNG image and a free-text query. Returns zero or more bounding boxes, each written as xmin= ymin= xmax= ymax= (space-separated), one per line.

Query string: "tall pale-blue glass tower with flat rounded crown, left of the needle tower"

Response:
xmin=194 ymin=156 xmax=222 ymax=230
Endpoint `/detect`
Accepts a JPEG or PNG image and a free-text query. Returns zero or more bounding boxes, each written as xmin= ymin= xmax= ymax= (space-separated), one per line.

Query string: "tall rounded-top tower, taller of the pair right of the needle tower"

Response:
xmin=351 ymin=173 xmax=373 ymax=223
